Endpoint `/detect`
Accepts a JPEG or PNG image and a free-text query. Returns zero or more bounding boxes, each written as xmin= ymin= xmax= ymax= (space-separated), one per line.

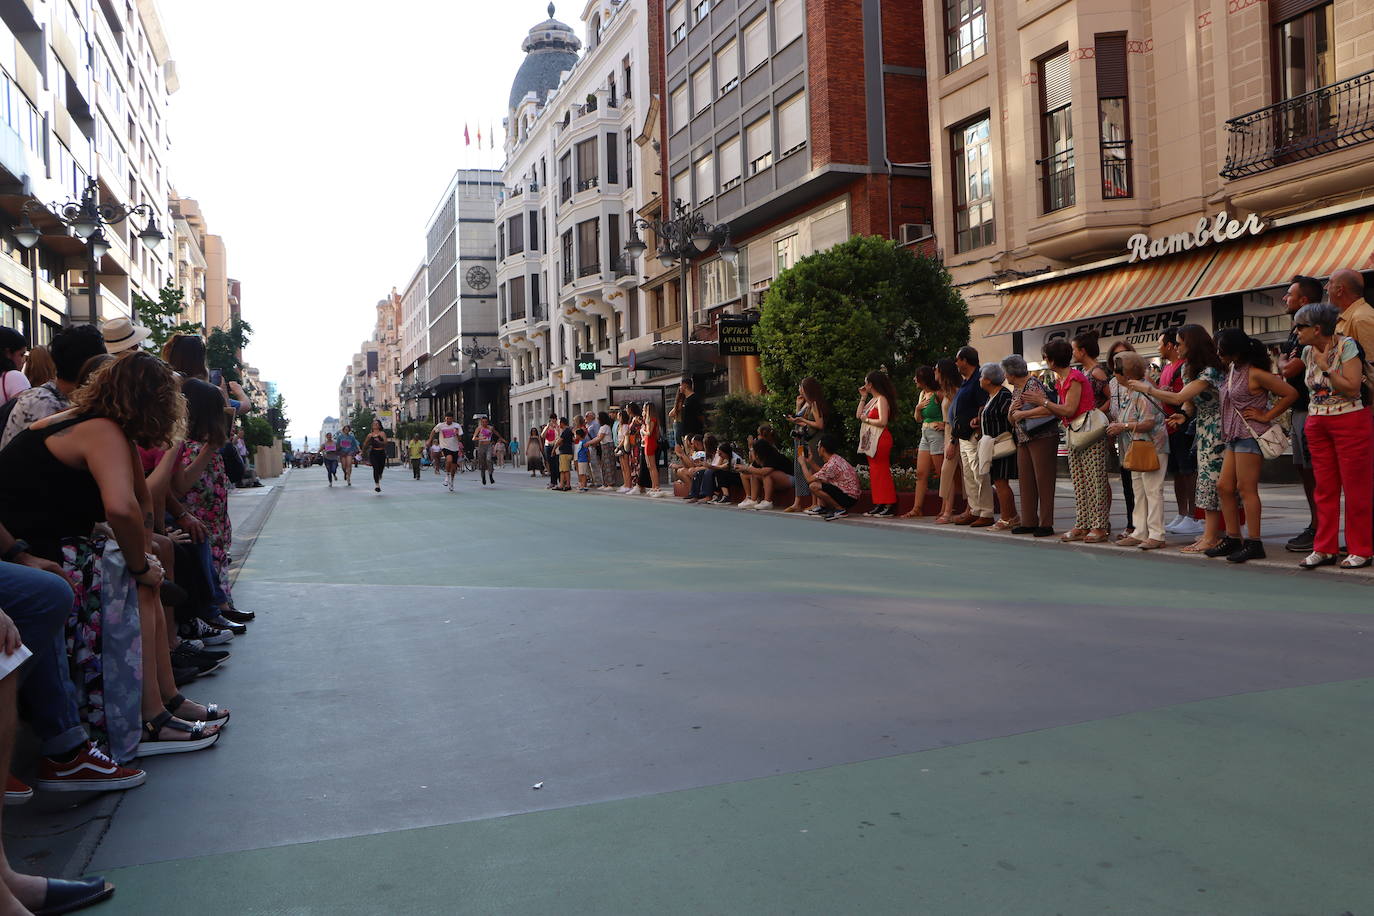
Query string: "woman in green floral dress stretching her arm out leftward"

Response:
xmin=1129 ymin=324 xmax=1226 ymax=553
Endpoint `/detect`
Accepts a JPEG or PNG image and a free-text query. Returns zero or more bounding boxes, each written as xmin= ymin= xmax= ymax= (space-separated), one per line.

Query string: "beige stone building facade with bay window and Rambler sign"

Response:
xmin=925 ymin=0 xmax=1374 ymax=360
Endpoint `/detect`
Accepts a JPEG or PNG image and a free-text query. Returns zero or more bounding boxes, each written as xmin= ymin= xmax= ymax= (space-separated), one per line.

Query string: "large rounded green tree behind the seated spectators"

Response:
xmin=756 ymin=236 xmax=969 ymax=453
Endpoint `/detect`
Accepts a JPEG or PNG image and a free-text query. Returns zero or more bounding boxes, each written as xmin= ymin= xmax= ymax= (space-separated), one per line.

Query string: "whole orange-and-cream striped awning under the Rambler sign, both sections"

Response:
xmin=988 ymin=210 xmax=1374 ymax=335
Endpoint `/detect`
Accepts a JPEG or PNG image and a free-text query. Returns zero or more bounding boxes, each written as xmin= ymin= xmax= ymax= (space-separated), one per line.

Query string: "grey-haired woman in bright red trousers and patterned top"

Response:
xmin=1293 ymin=304 xmax=1374 ymax=570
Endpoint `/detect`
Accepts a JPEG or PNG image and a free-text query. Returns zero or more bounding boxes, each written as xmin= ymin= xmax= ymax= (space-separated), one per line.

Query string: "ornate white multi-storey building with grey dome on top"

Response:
xmin=496 ymin=0 xmax=657 ymax=431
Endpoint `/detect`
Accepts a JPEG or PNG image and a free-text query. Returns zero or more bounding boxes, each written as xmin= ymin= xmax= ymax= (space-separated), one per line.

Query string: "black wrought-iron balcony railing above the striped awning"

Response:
xmin=1221 ymin=70 xmax=1374 ymax=179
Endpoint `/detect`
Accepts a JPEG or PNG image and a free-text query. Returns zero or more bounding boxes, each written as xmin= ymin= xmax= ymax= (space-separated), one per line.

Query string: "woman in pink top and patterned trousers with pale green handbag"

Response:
xmin=1024 ymin=338 xmax=1110 ymax=544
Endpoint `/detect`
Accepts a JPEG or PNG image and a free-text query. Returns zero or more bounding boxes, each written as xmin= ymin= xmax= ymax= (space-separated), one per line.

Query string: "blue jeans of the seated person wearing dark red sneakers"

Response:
xmin=0 ymin=562 xmax=87 ymax=757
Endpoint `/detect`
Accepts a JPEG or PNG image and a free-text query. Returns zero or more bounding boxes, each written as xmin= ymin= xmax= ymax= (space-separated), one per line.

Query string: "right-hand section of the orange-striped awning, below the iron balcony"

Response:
xmin=1193 ymin=210 xmax=1374 ymax=298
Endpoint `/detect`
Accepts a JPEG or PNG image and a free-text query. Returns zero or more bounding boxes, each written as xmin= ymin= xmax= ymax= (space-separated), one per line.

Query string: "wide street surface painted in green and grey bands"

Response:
xmin=91 ymin=470 xmax=1374 ymax=916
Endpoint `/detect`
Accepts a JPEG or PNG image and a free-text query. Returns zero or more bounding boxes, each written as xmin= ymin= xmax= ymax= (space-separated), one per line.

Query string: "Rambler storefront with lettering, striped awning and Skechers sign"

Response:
xmin=987 ymin=201 xmax=1374 ymax=363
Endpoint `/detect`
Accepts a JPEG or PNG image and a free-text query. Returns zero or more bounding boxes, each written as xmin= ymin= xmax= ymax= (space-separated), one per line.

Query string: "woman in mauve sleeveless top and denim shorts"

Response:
xmin=1205 ymin=328 xmax=1297 ymax=563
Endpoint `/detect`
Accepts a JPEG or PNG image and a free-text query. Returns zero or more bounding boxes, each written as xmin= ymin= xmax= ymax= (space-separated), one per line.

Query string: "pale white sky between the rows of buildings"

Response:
xmin=159 ymin=0 xmax=546 ymax=445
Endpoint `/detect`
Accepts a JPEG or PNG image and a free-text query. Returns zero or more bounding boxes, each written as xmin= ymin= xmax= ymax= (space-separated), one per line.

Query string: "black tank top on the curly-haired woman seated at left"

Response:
xmin=0 ymin=416 xmax=106 ymax=563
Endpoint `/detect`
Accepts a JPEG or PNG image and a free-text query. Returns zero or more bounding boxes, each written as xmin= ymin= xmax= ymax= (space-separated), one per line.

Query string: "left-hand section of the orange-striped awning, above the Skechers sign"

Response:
xmin=988 ymin=250 xmax=1215 ymax=335
